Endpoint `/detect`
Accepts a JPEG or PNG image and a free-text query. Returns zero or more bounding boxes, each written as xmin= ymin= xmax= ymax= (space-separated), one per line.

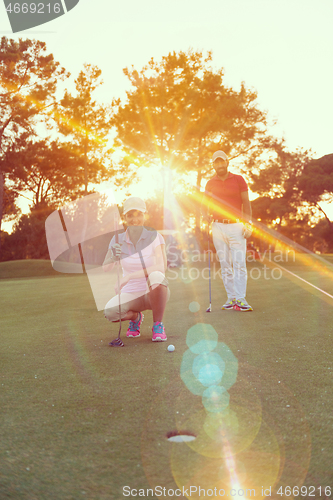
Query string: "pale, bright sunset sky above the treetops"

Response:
xmin=0 ymin=0 xmax=333 ymax=228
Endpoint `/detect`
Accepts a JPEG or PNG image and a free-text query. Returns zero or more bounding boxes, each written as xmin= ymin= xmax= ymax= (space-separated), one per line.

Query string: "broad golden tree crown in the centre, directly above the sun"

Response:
xmin=112 ymin=50 xmax=266 ymax=188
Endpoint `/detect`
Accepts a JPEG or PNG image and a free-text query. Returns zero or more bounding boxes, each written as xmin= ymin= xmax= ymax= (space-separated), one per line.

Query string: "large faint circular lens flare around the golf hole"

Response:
xmin=141 ymin=364 xmax=311 ymax=499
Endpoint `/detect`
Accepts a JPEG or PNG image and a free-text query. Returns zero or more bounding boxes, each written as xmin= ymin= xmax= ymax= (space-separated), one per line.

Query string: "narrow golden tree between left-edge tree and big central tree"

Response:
xmin=57 ymin=64 xmax=111 ymax=195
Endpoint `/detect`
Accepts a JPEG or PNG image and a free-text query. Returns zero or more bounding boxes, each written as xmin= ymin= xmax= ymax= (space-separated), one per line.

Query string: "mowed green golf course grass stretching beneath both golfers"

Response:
xmin=0 ymin=257 xmax=333 ymax=500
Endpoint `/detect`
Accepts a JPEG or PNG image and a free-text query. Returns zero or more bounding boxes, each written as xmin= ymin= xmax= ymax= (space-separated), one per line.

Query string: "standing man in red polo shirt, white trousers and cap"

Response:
xmin=202 ymin=151 xmax=252 ymax=311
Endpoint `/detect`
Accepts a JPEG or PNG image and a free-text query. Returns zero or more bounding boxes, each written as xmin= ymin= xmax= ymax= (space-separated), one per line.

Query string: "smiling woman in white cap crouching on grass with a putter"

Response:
xmin=103 ymin=197 xmax=170 ymax=342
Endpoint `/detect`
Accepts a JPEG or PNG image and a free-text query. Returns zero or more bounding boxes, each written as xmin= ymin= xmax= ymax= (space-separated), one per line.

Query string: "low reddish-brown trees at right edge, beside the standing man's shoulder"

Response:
xmin=249 ymin=140 xmax=333 ymax=250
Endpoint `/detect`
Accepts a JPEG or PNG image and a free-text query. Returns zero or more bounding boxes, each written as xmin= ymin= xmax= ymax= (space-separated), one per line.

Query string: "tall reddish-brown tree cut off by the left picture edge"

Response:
xmin=0 ymin=37 xmax=67 ymax=254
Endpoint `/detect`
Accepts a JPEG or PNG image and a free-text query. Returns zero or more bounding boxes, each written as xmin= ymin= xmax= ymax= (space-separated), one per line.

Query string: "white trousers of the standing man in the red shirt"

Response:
xmin=212 ymin=222 xmax=247 ymax=300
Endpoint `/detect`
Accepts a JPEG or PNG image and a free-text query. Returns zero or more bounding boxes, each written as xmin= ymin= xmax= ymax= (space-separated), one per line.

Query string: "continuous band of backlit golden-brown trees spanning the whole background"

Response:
xmin=0 ymin=42 xmax=333 ymax=258
